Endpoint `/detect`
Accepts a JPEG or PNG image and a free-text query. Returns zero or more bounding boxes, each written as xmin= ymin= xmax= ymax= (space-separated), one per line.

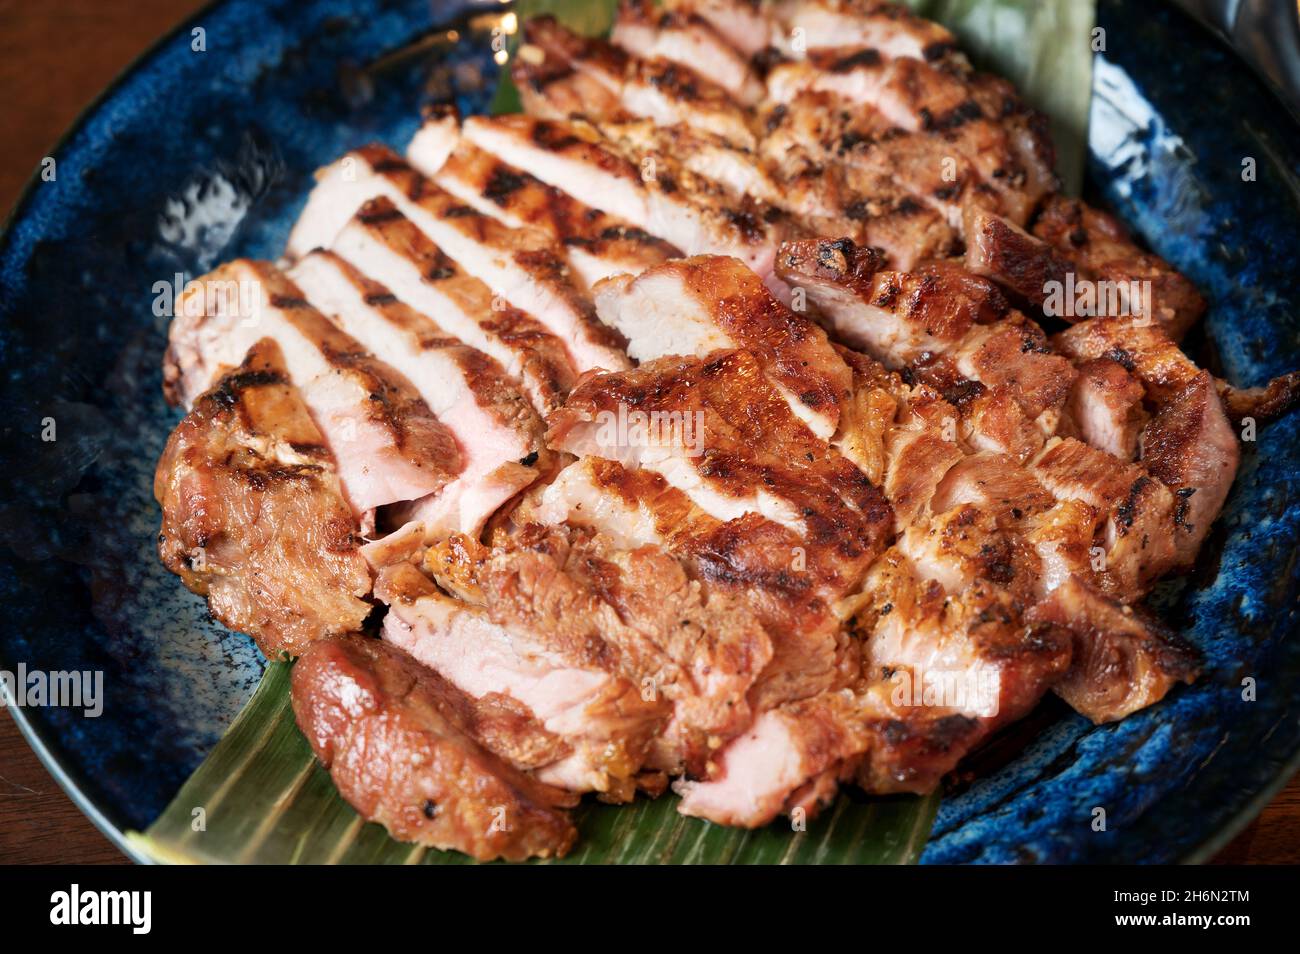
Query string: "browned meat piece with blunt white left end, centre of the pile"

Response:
xmin=595 ymin=256 xmax=852 ymax=439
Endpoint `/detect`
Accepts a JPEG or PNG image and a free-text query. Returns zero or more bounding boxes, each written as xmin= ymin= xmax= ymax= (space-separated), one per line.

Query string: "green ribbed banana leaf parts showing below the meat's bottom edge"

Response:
xmin=127 ymin=663 xmax=939 ymax=864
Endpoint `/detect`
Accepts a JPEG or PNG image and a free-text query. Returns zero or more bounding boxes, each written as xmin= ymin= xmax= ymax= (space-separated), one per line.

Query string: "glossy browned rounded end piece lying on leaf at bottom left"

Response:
xmin=293 ymin=637 xmax=577 ymax=860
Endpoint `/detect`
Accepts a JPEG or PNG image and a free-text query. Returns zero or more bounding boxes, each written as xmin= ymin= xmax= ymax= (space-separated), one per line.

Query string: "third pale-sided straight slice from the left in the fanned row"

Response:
xmin=332 ymin=199 xmax=577 ymax=413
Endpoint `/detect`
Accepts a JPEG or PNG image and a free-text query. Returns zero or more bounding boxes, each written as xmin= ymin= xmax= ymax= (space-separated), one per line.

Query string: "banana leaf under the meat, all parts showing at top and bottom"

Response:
xmin=127 ymin=0 xmax=1096 ymax=864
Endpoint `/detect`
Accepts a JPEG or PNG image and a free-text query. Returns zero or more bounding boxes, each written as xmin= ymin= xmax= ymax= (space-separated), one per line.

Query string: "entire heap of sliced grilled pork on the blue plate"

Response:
xmin=149 ymin=0 xmax=1300 ymax=858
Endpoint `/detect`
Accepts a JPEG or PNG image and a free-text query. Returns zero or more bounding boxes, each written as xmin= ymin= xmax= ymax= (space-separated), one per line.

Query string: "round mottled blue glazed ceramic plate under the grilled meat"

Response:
xmin=0 ymin=0 xmax=1300 ymax=862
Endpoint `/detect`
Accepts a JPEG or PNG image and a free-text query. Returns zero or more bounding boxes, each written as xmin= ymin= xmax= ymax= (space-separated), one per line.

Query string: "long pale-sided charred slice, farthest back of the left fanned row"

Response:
xmin=463 ymin=116 xmax=779 ymax=278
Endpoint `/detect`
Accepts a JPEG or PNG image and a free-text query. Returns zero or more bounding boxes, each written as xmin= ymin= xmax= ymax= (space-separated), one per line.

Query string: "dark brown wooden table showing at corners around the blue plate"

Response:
xmin=0 ymin=0 xmax=1300 ymax=864
